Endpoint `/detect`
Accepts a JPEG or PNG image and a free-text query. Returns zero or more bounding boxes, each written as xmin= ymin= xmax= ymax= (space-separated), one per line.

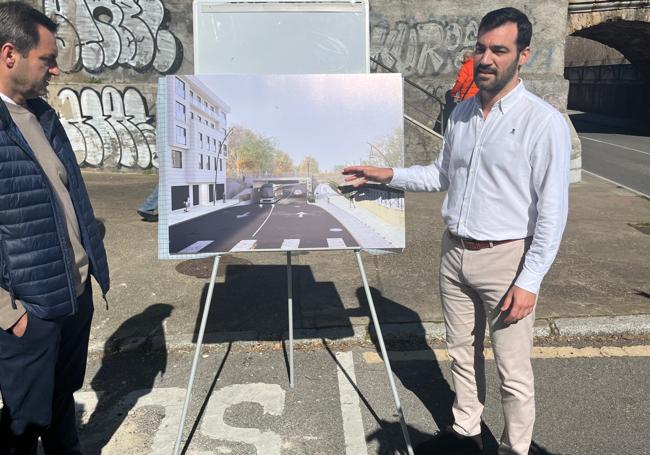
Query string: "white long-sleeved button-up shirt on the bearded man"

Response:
xmin=390 ymin=82 xmax=571 ymax=294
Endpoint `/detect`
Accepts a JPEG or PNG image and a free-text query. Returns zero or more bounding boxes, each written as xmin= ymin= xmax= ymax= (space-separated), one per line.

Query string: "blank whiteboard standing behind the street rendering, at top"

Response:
xmin=194 ymin=0 xmax=370 ymax=74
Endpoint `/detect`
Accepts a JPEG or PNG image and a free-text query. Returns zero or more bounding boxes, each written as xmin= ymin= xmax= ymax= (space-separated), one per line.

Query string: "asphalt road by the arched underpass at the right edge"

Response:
xmin=571 ymin=113 xmax=650 ymax=196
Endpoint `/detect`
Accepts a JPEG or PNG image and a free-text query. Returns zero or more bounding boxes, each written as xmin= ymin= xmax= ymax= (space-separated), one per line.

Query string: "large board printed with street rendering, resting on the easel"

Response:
xmin=157 ymin=74 xmax=405 ymax=258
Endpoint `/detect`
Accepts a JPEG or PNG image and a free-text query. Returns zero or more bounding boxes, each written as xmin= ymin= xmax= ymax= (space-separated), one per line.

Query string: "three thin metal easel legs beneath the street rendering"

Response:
xmin=173 ymin=250 xmax=413 ymax=455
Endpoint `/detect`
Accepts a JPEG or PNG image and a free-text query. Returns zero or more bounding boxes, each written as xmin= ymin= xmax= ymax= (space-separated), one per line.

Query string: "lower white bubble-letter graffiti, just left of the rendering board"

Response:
xmin=50 ymin=86 xmax=158 ymax=169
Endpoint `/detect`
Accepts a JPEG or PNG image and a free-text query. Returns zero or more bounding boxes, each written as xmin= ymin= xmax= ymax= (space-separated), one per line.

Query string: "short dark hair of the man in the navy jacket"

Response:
xmin=0 ymin=1 xmax=58 ymax=56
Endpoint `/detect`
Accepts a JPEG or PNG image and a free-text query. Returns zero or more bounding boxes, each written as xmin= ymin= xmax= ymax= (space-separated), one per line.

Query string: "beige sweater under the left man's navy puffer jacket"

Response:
xmin=0 ymin=96 xmax=88 ymax=330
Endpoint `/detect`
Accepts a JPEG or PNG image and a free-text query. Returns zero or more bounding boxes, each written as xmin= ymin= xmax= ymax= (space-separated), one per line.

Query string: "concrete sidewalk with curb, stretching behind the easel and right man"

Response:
xmin=84 ymin=171 xmax=650 ymax=351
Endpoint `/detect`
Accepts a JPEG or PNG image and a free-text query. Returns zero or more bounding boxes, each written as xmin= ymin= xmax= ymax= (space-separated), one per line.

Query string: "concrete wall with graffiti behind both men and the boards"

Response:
xmin=15 ymin=0 xmax=580 ymax=181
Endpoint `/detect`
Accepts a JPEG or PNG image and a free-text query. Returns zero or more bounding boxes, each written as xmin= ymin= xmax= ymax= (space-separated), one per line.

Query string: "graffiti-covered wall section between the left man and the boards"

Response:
xmin=33 ymin=0 xmax=185 ymax=171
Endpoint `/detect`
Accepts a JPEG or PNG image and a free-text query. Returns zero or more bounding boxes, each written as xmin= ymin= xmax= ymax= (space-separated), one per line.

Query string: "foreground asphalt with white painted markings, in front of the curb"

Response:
xmin=62 ymin=340 xmax=650 ymax=455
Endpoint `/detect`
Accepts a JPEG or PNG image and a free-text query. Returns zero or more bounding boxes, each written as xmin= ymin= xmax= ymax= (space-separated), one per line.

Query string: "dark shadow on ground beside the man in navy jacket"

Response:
xmin=81 ymin=303 xmax=173 ymax=454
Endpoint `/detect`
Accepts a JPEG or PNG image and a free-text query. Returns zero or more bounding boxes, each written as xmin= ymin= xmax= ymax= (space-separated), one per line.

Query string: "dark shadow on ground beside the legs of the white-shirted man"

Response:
xmin=356 ymin=288 xmax=497 ymax=453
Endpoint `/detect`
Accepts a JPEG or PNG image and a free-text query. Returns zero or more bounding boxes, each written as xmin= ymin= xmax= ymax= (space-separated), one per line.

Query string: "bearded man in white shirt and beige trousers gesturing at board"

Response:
xmin=343 ymin=8 xmax=571 ymax=455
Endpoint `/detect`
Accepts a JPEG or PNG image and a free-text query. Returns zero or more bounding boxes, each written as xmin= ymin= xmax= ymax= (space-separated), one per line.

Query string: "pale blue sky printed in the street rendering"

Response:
xmin=196 ymin=74 xmax=403 ymax=171
